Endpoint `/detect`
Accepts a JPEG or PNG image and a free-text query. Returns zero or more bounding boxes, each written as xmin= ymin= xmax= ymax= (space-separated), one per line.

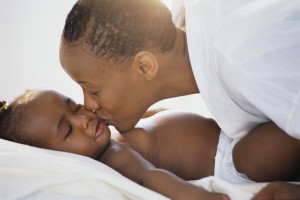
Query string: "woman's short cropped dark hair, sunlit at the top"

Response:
xmin=63 ymin=0 xmax=176 ymax=61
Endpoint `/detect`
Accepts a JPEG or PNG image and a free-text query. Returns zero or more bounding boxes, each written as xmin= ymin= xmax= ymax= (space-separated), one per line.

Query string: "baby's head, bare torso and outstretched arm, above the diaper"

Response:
xmin=0 ymin=90 xmax=229 ymax=200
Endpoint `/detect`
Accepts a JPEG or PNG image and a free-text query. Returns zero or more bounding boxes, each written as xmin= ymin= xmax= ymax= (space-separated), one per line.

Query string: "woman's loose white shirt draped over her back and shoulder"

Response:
xmin=185 ymin=0 xmax=300 ymax=139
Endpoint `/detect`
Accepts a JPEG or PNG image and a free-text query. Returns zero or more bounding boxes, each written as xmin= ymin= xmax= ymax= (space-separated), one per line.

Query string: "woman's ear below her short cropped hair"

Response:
xmin=133 ymin=51 xmax=158 ymax=80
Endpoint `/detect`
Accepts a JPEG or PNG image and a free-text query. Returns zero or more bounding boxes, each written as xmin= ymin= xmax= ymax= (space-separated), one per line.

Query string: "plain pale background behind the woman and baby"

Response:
xmin=0 ymin=0 xmax=210 ymax=116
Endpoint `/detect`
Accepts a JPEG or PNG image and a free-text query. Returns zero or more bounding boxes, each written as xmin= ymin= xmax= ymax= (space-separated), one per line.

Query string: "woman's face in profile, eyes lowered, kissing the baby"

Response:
xmin=60 ymin=42 xmax=152 ymax=132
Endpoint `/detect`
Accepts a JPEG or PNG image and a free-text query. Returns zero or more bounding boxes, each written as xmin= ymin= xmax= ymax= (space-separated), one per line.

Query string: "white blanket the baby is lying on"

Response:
xmin=0 ymin=139 xmax=266 ymax=200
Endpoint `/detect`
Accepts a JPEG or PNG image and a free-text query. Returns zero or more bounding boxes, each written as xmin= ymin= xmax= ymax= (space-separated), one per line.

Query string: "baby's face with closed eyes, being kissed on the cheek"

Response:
xmin=22 ymin=91 xmax=111 ymax=158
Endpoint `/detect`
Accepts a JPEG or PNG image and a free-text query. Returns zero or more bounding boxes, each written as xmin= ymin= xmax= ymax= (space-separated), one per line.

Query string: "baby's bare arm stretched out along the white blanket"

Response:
xmin=100 ymin=141 xmax=229 ymax=199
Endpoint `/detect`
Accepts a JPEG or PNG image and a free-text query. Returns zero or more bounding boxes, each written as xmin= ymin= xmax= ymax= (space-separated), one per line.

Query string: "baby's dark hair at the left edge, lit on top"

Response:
xmin=0 ymin=90 xmax=36 ymax=146
